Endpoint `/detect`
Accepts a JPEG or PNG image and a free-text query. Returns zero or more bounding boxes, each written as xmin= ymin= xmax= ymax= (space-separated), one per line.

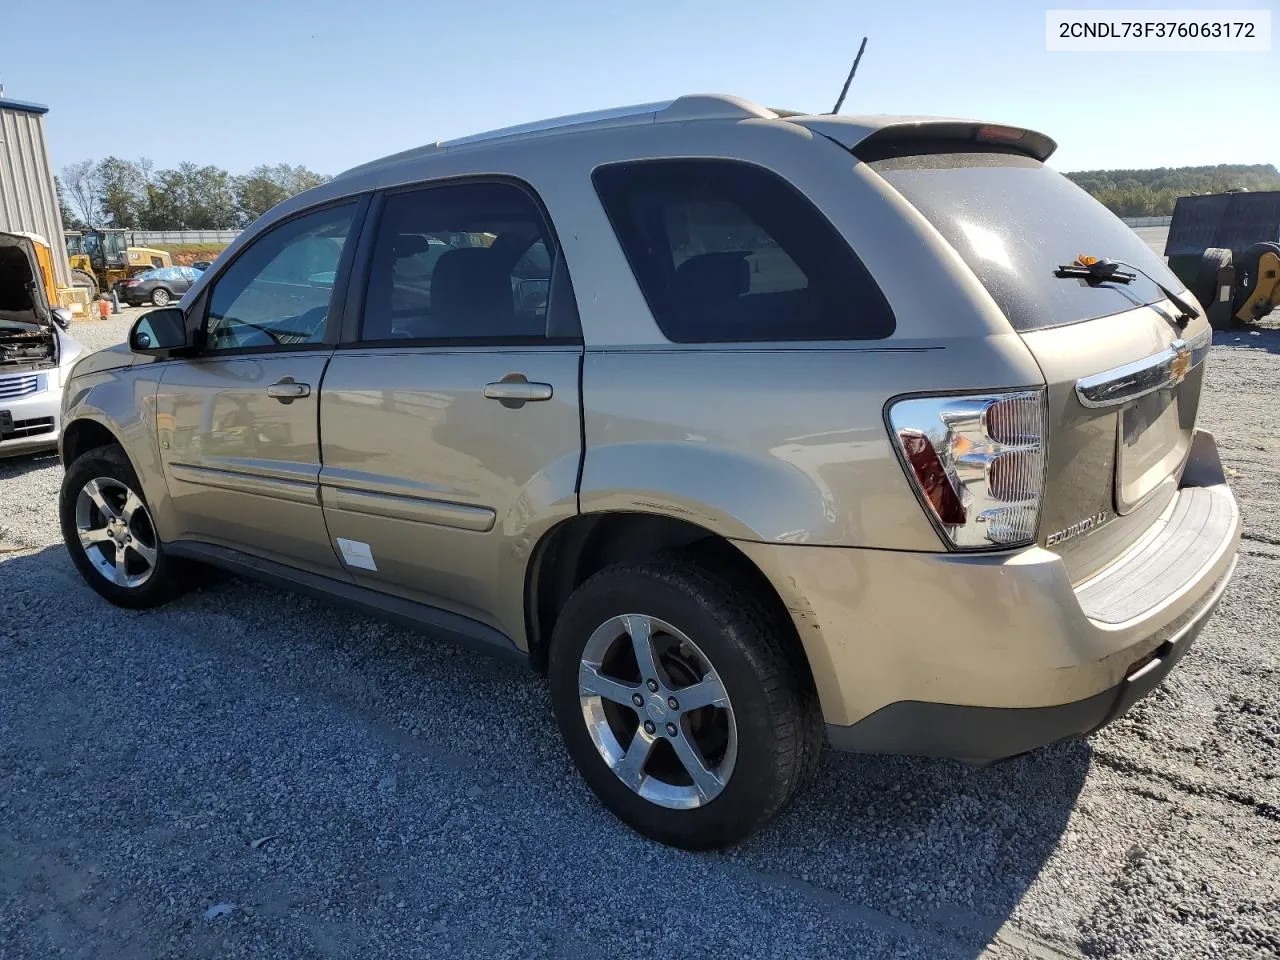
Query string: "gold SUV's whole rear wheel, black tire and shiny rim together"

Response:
xmin=548 ymin=554 xmax=823 ymax=850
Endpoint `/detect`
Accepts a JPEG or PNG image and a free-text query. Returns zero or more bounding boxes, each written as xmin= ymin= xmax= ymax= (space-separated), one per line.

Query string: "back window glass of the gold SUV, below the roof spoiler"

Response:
xmin=869 ymin=154 xmax=1183 ymax=330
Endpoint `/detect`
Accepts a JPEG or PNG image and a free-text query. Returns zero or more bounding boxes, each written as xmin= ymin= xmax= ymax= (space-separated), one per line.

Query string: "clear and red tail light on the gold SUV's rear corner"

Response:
xmin=888 ymin=390 xmax=1047 ymax=549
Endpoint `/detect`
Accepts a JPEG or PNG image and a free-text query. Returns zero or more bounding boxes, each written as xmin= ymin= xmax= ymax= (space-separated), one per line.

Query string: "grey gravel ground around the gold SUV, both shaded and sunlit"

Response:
xmin=0 ymin=312 xmax=1280 ymax=960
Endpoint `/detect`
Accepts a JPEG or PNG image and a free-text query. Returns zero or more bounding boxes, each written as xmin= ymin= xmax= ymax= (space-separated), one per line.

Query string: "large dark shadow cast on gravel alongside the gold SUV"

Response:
xmin=0 ymin=547 xmax=1091 ymax=960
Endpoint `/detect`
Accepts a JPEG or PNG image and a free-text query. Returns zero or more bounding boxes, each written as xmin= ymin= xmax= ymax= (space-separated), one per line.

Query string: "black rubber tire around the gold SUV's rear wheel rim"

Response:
xmin=548 ymin=554 xmax=823 ymax=850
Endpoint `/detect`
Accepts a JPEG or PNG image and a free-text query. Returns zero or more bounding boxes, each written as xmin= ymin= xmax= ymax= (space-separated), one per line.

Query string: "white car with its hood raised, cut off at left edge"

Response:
xmin=0 ymin=233 xmax=83 ymax=457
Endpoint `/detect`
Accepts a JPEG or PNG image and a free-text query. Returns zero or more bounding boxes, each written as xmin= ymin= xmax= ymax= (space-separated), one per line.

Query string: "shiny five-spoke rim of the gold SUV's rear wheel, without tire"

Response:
xmin=577 ymin=613 xmax=737 ymax=809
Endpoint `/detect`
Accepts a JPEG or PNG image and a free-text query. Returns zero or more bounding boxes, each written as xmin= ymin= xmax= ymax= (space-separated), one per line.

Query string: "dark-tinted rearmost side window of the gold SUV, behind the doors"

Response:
xmin=593 ymin=160 xmax=893 ymax=343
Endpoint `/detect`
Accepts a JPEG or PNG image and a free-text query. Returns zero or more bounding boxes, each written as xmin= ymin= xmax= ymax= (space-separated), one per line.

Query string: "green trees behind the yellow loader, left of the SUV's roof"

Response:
xmin=55 ymin=156 xmax=329 ymax=230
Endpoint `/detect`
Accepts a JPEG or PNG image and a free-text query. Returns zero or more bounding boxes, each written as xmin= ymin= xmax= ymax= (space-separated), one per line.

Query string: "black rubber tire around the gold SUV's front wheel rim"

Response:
xmin=58 ymin=444 xmax=187 ymax=609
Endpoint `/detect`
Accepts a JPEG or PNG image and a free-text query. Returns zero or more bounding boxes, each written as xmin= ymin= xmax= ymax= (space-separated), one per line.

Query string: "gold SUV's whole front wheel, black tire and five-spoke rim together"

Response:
xmin=59 ymin=445 xmax=183 ymax=608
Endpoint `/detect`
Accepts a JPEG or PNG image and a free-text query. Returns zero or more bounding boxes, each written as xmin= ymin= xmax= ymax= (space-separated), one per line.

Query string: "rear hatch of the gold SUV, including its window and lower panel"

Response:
xmin=855 ymin=141 xmax=1211 ymax=582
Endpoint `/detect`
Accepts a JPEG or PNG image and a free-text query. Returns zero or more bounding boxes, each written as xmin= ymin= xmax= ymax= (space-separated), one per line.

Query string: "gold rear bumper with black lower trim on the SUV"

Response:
xmin=739 ymin=431 xmax=1240 ymax=762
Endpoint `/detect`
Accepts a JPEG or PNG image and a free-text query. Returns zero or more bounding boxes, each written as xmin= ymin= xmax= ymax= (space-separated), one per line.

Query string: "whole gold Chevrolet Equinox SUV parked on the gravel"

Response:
xmin=60 ymin=96 xmax=1240 ymax=847
